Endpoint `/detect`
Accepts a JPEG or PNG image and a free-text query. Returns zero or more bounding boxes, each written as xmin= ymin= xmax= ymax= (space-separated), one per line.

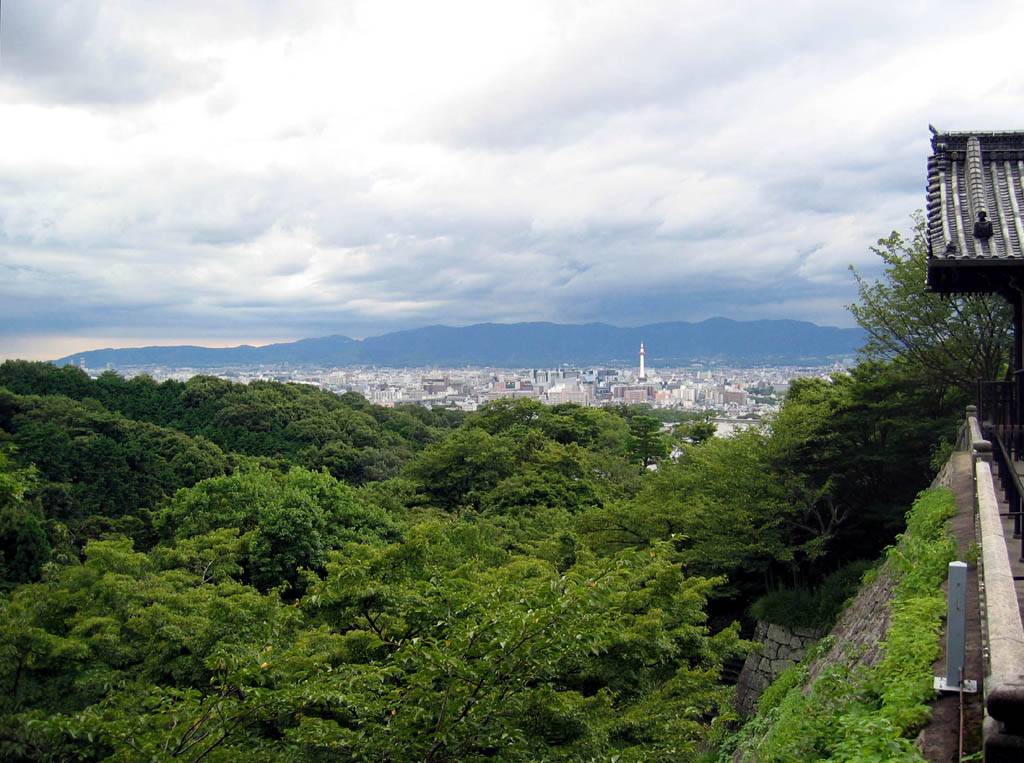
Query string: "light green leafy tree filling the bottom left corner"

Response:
xmin=0 ymin=534 xmax=298 ymax=760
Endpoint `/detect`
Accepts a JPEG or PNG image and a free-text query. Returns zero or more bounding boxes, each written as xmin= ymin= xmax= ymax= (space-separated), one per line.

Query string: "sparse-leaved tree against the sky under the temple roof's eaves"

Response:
xmin=849 ymin=213 xmax=1013 ymax=397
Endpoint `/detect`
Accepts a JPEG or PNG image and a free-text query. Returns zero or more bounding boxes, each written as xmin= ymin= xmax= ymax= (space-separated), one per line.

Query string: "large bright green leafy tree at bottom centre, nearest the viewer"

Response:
xmin=296 ymin=524 xmax=739 ymax=761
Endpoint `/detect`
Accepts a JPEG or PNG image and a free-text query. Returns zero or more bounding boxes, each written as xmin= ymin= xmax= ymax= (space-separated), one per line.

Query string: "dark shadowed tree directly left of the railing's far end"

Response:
xmin=772 ymin=362 xmax=963 ymax=571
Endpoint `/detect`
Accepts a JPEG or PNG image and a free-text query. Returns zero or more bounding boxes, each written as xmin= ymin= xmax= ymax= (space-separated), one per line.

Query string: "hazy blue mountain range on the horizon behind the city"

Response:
xmin=54 ymin=317 xmax=863 ymax=369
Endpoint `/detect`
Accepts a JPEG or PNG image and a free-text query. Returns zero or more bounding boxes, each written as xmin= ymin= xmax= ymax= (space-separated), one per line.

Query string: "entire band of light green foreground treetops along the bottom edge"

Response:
xmin=0 ymin=522 xmax=743 ymax=761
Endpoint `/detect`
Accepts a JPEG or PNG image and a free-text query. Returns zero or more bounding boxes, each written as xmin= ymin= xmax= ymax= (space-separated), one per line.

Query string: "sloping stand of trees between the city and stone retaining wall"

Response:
xmin=581 ymin=364 xmax=942 ymax=619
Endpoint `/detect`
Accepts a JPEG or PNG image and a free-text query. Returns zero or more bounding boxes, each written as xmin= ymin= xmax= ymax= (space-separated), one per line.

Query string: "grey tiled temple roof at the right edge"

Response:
xmin=928 ymin=130 xmax=1024 ymax=264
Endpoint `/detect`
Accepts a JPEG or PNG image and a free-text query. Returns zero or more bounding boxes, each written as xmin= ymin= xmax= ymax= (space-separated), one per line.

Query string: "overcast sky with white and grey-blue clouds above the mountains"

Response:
xmin=0 ymin=0 xmax=1024 ymax=358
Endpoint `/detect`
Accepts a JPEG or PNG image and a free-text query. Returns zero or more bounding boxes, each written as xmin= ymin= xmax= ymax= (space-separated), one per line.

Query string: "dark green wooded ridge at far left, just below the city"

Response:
xmin=0 ymin=361 xmax=462 ymax=483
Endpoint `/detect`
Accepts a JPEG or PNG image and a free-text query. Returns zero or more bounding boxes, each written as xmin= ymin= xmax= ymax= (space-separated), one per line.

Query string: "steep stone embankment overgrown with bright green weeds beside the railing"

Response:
xmin=721 ymin=454 xmax=981 ymax=763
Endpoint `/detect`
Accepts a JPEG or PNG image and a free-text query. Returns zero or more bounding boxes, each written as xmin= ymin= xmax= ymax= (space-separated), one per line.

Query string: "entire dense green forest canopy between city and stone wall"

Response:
xmin=0 ymin=348 xmax=961 ymax=761
